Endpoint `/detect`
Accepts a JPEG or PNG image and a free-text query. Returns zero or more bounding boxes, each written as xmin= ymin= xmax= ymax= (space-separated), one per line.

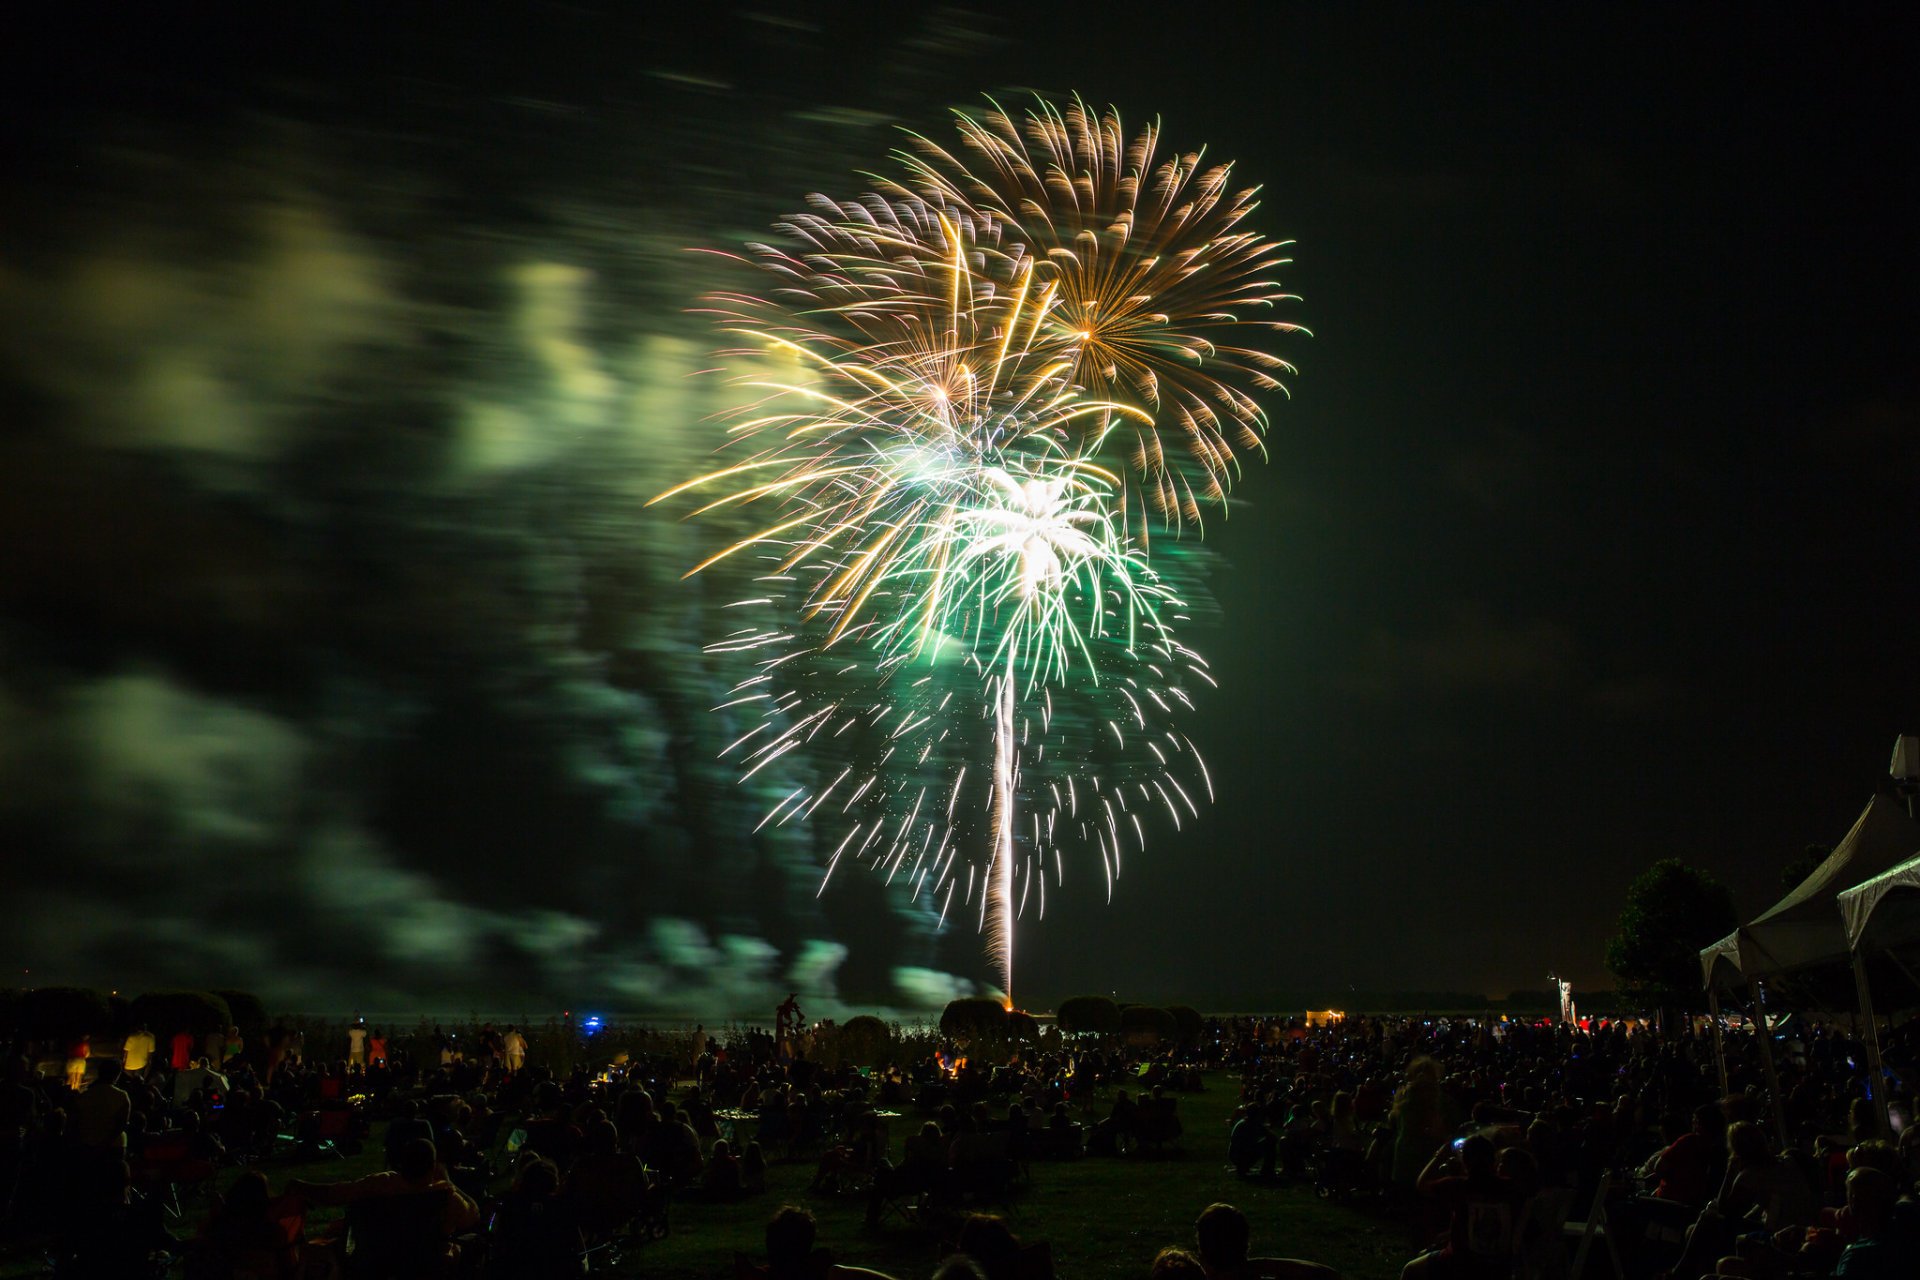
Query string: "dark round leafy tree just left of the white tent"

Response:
xmin=1607 ymin=858 xmax=1740 ymax=1009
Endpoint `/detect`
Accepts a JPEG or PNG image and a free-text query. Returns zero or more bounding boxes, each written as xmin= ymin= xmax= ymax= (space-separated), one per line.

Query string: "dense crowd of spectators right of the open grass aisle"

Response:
xmin=1213 ymin=1019 xmax=1920 ymax=1280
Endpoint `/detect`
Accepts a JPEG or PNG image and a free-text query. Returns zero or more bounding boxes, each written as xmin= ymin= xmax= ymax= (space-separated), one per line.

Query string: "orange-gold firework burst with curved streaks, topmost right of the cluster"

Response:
xmin=902 ymin=100 xmax=1304 ymax=520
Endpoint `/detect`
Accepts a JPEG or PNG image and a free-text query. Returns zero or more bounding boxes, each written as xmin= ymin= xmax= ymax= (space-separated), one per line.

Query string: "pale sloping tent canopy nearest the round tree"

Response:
xmin=1699 ymin=794 xmax=1920 ymax=988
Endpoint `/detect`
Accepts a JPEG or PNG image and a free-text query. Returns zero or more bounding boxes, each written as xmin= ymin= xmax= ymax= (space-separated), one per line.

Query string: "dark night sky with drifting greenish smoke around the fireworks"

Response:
xmin=0 ymin=4 xmax=1920 ymax=1006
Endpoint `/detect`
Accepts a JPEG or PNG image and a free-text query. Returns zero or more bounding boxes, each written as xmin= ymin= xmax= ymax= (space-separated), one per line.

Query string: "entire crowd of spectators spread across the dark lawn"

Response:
xmin=0 ymin=1017 xmax=1920 ymax=1280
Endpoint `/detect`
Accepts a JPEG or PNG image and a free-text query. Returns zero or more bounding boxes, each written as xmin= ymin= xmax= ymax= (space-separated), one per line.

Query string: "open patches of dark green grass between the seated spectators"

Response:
xmin=0 ymin=1075 xmax=1413 ymax=1280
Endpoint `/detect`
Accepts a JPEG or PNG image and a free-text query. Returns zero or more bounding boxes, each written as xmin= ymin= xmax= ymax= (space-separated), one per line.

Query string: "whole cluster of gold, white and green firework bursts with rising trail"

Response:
xmin=655 ymin=102 xmax=1298 ymax=1000
